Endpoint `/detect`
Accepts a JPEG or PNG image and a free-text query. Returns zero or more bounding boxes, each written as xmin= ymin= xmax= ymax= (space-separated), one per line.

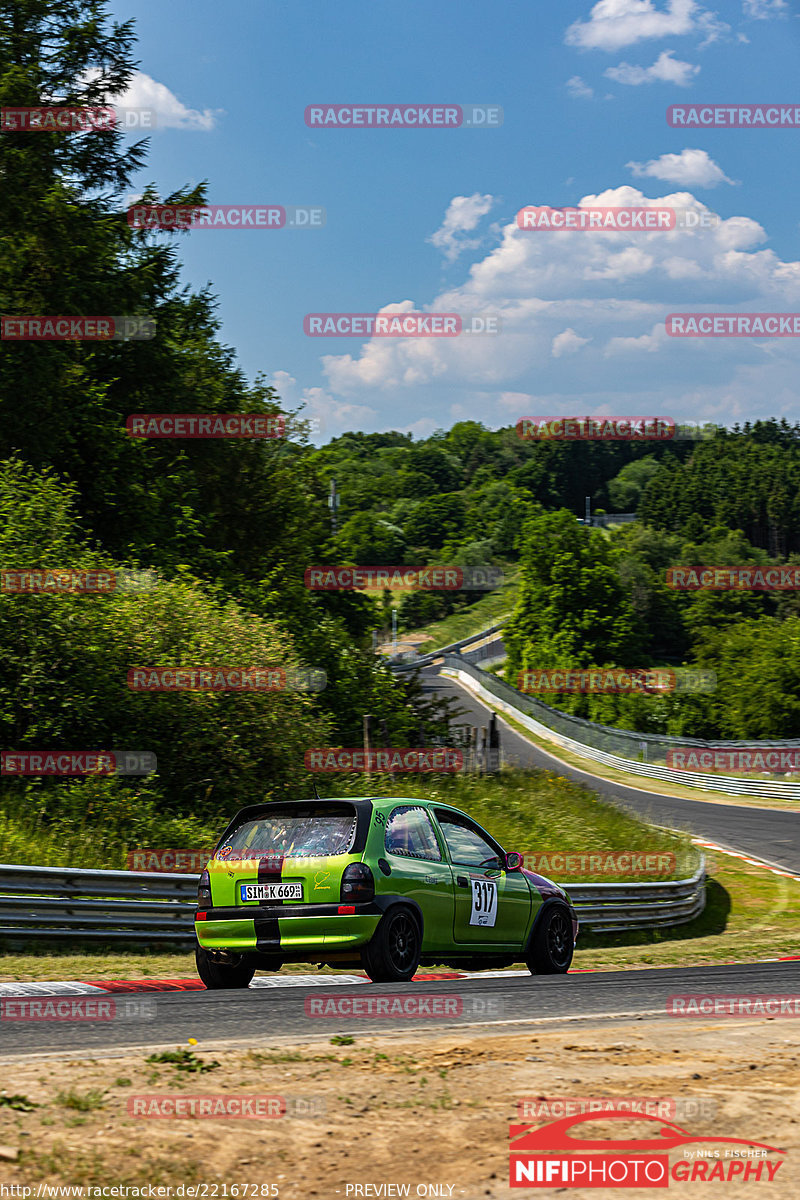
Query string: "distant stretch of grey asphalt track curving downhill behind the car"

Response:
xmin=422 ymin=667 xmax=800 ymax=875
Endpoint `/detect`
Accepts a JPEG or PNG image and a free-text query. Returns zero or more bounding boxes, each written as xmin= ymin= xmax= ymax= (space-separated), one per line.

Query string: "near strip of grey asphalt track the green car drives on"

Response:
xmin=0 ymin=961 xmax=800 ymax=1058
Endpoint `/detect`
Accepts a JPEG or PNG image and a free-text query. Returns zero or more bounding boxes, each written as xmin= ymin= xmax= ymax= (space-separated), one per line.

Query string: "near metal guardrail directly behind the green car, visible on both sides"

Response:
xmin=0 ymin=856 xmax=705 ymax=948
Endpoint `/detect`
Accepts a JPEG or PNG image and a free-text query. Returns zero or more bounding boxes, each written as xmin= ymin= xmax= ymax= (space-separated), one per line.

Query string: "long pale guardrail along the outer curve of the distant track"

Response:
xmin=440 ymin=654 xmax=800 ymax=800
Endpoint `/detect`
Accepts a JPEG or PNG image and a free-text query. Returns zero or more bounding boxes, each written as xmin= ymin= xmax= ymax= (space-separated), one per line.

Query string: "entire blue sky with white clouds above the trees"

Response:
xmin=112 ymin=0 xmax=800 ymax=440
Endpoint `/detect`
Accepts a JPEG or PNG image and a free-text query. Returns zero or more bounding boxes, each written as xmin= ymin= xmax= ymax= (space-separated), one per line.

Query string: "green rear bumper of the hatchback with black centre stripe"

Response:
xmin=194 ymin=904 xmax=383 ymax=956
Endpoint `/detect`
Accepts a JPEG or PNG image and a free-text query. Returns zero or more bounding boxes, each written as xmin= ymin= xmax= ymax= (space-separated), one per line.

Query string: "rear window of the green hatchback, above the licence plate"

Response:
xmin=216 ymin=806 xmax=356 ymax=859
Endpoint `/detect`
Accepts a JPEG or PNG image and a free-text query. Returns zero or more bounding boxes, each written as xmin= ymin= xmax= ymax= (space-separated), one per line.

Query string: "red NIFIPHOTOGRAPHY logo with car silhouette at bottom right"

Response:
xmin=509 ymin=1109 xmax=786 ymax=1188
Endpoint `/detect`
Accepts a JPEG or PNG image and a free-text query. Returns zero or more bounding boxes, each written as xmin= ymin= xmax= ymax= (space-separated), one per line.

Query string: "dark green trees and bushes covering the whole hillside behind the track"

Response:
xmin=0 ymin=0 xmax=800 ymax=864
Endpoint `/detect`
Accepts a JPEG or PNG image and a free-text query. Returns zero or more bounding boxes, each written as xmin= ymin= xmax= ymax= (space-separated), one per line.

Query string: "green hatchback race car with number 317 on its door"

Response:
xmin=194 ymin=796 xmax=578 ymax=988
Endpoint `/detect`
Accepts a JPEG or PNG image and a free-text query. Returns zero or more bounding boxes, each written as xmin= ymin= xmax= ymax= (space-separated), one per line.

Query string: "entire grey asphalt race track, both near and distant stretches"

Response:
xmin=0 ymin=652 xmax=800 ymax=1060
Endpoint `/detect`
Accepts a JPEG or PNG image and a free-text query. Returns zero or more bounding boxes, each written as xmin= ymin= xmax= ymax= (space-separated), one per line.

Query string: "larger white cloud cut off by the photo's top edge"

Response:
xmin=565 ymin=0 xmax=699 ymax=50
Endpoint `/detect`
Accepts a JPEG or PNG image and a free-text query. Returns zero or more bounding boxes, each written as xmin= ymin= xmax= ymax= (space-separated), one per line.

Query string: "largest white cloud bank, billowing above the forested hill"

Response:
xmin=311 ymin=186 xmax=800 ymax=428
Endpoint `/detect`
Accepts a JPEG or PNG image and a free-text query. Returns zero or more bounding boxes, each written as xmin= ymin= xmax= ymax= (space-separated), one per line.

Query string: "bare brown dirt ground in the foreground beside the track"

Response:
xmin=0 ymin=1019 xmax=800 ymax=1200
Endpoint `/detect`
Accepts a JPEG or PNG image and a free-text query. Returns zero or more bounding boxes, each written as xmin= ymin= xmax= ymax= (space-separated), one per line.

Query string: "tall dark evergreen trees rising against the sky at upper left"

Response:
xmin=0 ymin=0 xmax=325 ymax=583
